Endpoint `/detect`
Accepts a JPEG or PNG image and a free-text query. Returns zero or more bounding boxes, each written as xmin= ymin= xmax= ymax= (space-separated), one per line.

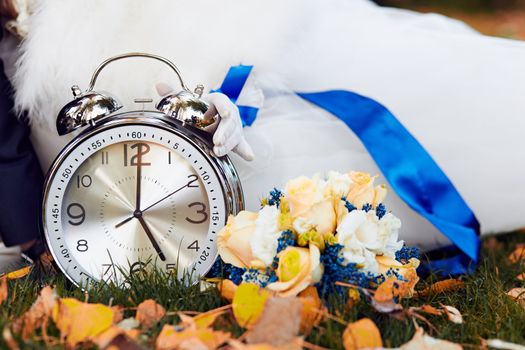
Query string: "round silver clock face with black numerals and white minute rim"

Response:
xmin=43 ymin=118 xmax=227 ymax=285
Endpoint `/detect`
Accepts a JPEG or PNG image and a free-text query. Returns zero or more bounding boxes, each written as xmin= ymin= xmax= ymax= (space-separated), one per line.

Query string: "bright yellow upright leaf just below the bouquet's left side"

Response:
xmin=232 ymin=283 xmax=270 ymax=329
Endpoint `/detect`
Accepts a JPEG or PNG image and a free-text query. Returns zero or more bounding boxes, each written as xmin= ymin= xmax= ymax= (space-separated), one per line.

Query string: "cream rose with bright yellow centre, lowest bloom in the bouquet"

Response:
xmin=267 ymin=244 xmax=323 ymax=297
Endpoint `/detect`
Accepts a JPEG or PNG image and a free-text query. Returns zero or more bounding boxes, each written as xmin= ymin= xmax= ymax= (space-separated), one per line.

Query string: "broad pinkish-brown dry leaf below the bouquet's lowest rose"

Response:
xmin=246 ymin=297 xmax=303 ymax=346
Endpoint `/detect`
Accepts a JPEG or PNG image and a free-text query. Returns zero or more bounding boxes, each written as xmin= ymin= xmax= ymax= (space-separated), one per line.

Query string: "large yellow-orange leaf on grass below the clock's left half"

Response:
xmin=52 ymin=298 xmax=113 ymax=347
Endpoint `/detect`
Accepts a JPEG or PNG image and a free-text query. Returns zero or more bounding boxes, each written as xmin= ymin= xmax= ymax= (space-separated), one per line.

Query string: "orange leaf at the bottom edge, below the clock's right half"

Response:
xmin=155 ymin=317 xmax=231 ymax=350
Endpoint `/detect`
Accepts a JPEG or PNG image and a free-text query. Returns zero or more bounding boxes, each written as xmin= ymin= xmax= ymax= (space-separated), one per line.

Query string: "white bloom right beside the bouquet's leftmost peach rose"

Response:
xmin=250 ymin=205 xmax=281 ymax=265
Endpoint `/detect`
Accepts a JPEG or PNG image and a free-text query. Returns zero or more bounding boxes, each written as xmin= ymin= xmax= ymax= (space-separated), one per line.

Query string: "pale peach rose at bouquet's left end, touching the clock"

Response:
xmin=217 ymin=211 xmax=258 ymax=267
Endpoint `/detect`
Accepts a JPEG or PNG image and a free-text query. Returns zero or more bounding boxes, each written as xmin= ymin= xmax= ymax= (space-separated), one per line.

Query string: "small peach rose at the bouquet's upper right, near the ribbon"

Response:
xmin=346 ymin=171 xmax=386 ymax=209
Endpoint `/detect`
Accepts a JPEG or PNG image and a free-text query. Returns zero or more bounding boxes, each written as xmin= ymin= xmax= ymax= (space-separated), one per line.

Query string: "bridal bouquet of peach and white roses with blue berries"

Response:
xmin=211 ymin=172 xmax=419 ymax=297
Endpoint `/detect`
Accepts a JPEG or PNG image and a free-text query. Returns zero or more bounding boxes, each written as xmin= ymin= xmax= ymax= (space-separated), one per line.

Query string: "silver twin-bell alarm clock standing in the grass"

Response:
xmin=42 ymin=53 xmax=244 ymax=287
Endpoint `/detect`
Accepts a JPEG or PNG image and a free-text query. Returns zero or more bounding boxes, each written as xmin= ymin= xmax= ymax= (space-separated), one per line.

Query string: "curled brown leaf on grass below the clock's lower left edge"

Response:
xmin=13 ymin=286 xmax=58 ymax=341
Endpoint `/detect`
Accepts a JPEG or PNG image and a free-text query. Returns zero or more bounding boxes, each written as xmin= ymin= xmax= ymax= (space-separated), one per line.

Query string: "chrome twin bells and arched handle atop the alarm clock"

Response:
xmin=57 ymin=52 xmax=217 ymax=135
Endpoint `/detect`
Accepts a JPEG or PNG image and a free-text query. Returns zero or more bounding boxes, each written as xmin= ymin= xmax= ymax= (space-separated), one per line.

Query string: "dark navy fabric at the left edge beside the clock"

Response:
xmin=0 ymin=56 xmax=44 ymax=247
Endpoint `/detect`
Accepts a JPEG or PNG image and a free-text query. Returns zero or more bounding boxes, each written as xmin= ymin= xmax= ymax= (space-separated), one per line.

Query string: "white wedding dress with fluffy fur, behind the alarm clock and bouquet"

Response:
xmin=7 ymin=0 xmax=525 ymax=249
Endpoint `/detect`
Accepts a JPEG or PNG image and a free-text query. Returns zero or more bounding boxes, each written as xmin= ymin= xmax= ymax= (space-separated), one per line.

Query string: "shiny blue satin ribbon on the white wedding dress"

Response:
xmin=218 ymin=65 xmax=480 ymax=274
